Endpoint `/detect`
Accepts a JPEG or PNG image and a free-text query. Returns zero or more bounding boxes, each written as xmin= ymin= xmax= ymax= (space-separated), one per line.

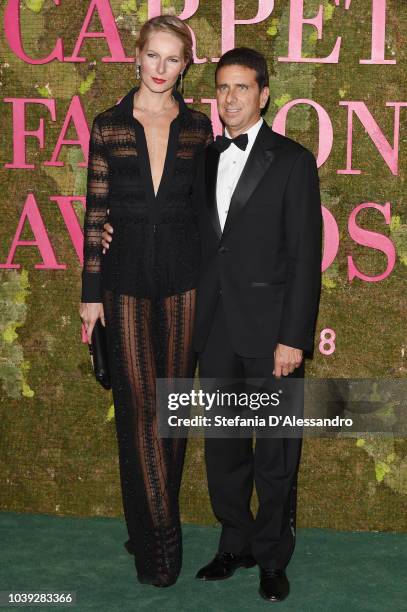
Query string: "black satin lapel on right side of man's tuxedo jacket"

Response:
xmin=222 ymin=122 xmax=280 ymax=236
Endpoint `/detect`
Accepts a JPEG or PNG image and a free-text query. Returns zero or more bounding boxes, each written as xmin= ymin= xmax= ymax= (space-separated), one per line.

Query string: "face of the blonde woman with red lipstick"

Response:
xmin=136 ymin=32 xmax=185 ymax=93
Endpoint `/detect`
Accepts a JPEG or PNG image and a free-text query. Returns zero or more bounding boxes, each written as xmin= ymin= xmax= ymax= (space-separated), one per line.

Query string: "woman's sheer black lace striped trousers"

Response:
xmin=103 ymin=290 xmax=195 ymax=585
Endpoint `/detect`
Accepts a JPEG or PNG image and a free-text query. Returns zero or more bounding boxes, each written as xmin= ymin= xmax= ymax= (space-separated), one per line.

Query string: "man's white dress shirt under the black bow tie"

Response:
xmin=216 ymin=118 xmax=263 ymax=232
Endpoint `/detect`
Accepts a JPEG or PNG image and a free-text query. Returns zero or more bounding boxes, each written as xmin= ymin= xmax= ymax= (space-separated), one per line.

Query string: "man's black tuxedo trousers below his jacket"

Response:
xmin=199 ymin=297 xmax=304 ymax=569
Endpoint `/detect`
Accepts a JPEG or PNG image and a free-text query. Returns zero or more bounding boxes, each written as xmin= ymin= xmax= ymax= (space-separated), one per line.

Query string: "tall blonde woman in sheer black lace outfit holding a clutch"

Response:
xmin=80 ymin=15 xmax=213 ymax=586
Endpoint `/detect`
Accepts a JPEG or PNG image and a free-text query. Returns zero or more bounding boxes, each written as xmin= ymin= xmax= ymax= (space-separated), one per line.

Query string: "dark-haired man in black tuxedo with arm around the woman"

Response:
xmin=103 ymin=48 xmax=321 ymax=602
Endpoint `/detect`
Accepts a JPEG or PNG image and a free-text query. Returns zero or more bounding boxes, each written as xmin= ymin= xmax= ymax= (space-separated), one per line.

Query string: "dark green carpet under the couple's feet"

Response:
xmin=0 ymin=512 xmax=407 ymax=612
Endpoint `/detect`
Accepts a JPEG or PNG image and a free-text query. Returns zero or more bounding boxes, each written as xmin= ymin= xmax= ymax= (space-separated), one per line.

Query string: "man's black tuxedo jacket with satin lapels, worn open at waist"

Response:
xmin=193 ymin=122 xmax=322 ymax=358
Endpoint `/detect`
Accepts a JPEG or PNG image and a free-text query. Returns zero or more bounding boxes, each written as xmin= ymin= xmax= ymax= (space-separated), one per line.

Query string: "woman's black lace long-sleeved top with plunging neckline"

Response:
xmin=81 ymin=87 xmax=213 ymax=302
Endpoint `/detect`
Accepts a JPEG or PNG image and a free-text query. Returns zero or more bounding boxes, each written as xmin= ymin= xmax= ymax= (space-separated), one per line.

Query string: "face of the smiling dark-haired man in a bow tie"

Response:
xmin=216 ymin=65 xmax=270 ymax=138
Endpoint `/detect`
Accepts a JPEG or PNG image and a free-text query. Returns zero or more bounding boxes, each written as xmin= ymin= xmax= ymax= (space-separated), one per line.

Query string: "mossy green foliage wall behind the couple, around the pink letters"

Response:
xmin=0 ymin=0 xmax=407 ymax=530
